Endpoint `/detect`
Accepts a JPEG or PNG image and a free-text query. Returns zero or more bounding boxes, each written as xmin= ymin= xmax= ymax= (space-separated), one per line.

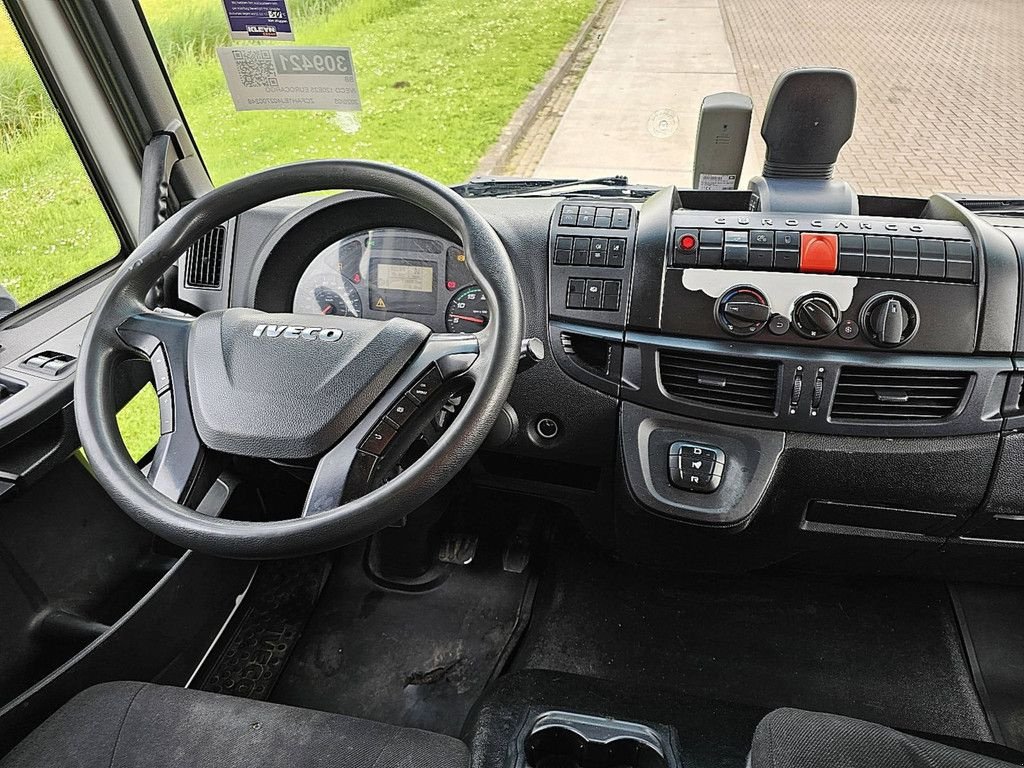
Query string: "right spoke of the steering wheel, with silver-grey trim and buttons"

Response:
xmin=302 ymin=334 xmax=480 ymax=517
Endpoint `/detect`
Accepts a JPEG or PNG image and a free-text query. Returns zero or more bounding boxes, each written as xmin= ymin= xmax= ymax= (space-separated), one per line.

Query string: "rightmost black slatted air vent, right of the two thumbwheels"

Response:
xmin=831 ymin=368 xmax=971 ymax=422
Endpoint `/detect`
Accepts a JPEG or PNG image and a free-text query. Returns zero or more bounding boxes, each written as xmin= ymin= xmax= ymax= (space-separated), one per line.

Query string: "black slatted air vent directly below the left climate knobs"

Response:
xmin=658 ymin=350 xmax=779 ymax=414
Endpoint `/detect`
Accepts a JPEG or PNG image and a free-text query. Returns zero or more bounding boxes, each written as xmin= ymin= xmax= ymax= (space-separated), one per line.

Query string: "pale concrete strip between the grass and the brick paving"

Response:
xmin=532 ymin=0 xmax=756 ymax=186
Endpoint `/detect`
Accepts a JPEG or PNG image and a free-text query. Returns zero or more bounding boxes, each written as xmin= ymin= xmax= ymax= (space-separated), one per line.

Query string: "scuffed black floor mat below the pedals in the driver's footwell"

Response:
xmin=272 ymin=528 xmax=536 ymax=735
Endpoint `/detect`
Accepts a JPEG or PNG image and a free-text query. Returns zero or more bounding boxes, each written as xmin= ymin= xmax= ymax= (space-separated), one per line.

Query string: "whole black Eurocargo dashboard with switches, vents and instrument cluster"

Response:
xmin=6 ymin=187 xmax=1024 ymax=578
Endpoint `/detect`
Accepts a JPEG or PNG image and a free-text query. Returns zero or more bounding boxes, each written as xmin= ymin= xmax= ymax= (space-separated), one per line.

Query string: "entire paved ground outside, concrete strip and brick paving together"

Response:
xmin=524 ymin=0 xmax=1024 ymax=195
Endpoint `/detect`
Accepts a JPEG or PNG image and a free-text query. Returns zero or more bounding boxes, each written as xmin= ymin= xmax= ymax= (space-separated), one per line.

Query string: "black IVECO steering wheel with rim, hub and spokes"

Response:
xmin=75 ymin=160 xmax=523 ymax=559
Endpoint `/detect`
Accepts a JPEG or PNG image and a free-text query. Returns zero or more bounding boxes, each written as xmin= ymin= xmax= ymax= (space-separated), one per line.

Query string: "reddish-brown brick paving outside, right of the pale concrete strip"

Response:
xmin=721 ymin=0 xmax=1024 ymax=195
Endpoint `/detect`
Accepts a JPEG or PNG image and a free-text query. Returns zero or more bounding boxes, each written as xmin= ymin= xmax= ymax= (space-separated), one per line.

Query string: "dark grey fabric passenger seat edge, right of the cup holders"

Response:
xmin=749 ymin=709 xmax=1024 ymax=768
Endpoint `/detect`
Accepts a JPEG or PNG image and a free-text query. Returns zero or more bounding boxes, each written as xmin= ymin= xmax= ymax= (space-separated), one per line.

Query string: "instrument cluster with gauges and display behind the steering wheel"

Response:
xmin=292 ymin=226 xmax=489 ymax=333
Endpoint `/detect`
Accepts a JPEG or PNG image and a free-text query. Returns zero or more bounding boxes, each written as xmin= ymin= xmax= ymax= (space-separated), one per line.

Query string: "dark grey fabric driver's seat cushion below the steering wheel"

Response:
xmin=0 ymin=683 xmax=469 ymax=768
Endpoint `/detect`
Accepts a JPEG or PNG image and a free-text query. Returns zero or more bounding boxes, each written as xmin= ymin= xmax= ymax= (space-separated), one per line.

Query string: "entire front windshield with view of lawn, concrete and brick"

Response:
xmin=141 ymin=0 xmax=1024 ymax=196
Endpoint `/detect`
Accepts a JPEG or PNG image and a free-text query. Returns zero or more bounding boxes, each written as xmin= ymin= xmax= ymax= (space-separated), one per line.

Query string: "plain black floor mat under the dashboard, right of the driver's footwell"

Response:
xmin=514 ymin=536 xmax=991 ymax=740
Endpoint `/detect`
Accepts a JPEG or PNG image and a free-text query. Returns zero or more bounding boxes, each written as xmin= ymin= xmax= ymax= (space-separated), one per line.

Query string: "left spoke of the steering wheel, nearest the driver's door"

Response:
xmin=117 ymin=310 xmax=207 ymax=504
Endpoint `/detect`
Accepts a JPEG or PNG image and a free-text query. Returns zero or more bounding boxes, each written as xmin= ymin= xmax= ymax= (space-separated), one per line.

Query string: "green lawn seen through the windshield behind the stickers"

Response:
xmin=141 ymin=0 xmax=594 ymax=183
